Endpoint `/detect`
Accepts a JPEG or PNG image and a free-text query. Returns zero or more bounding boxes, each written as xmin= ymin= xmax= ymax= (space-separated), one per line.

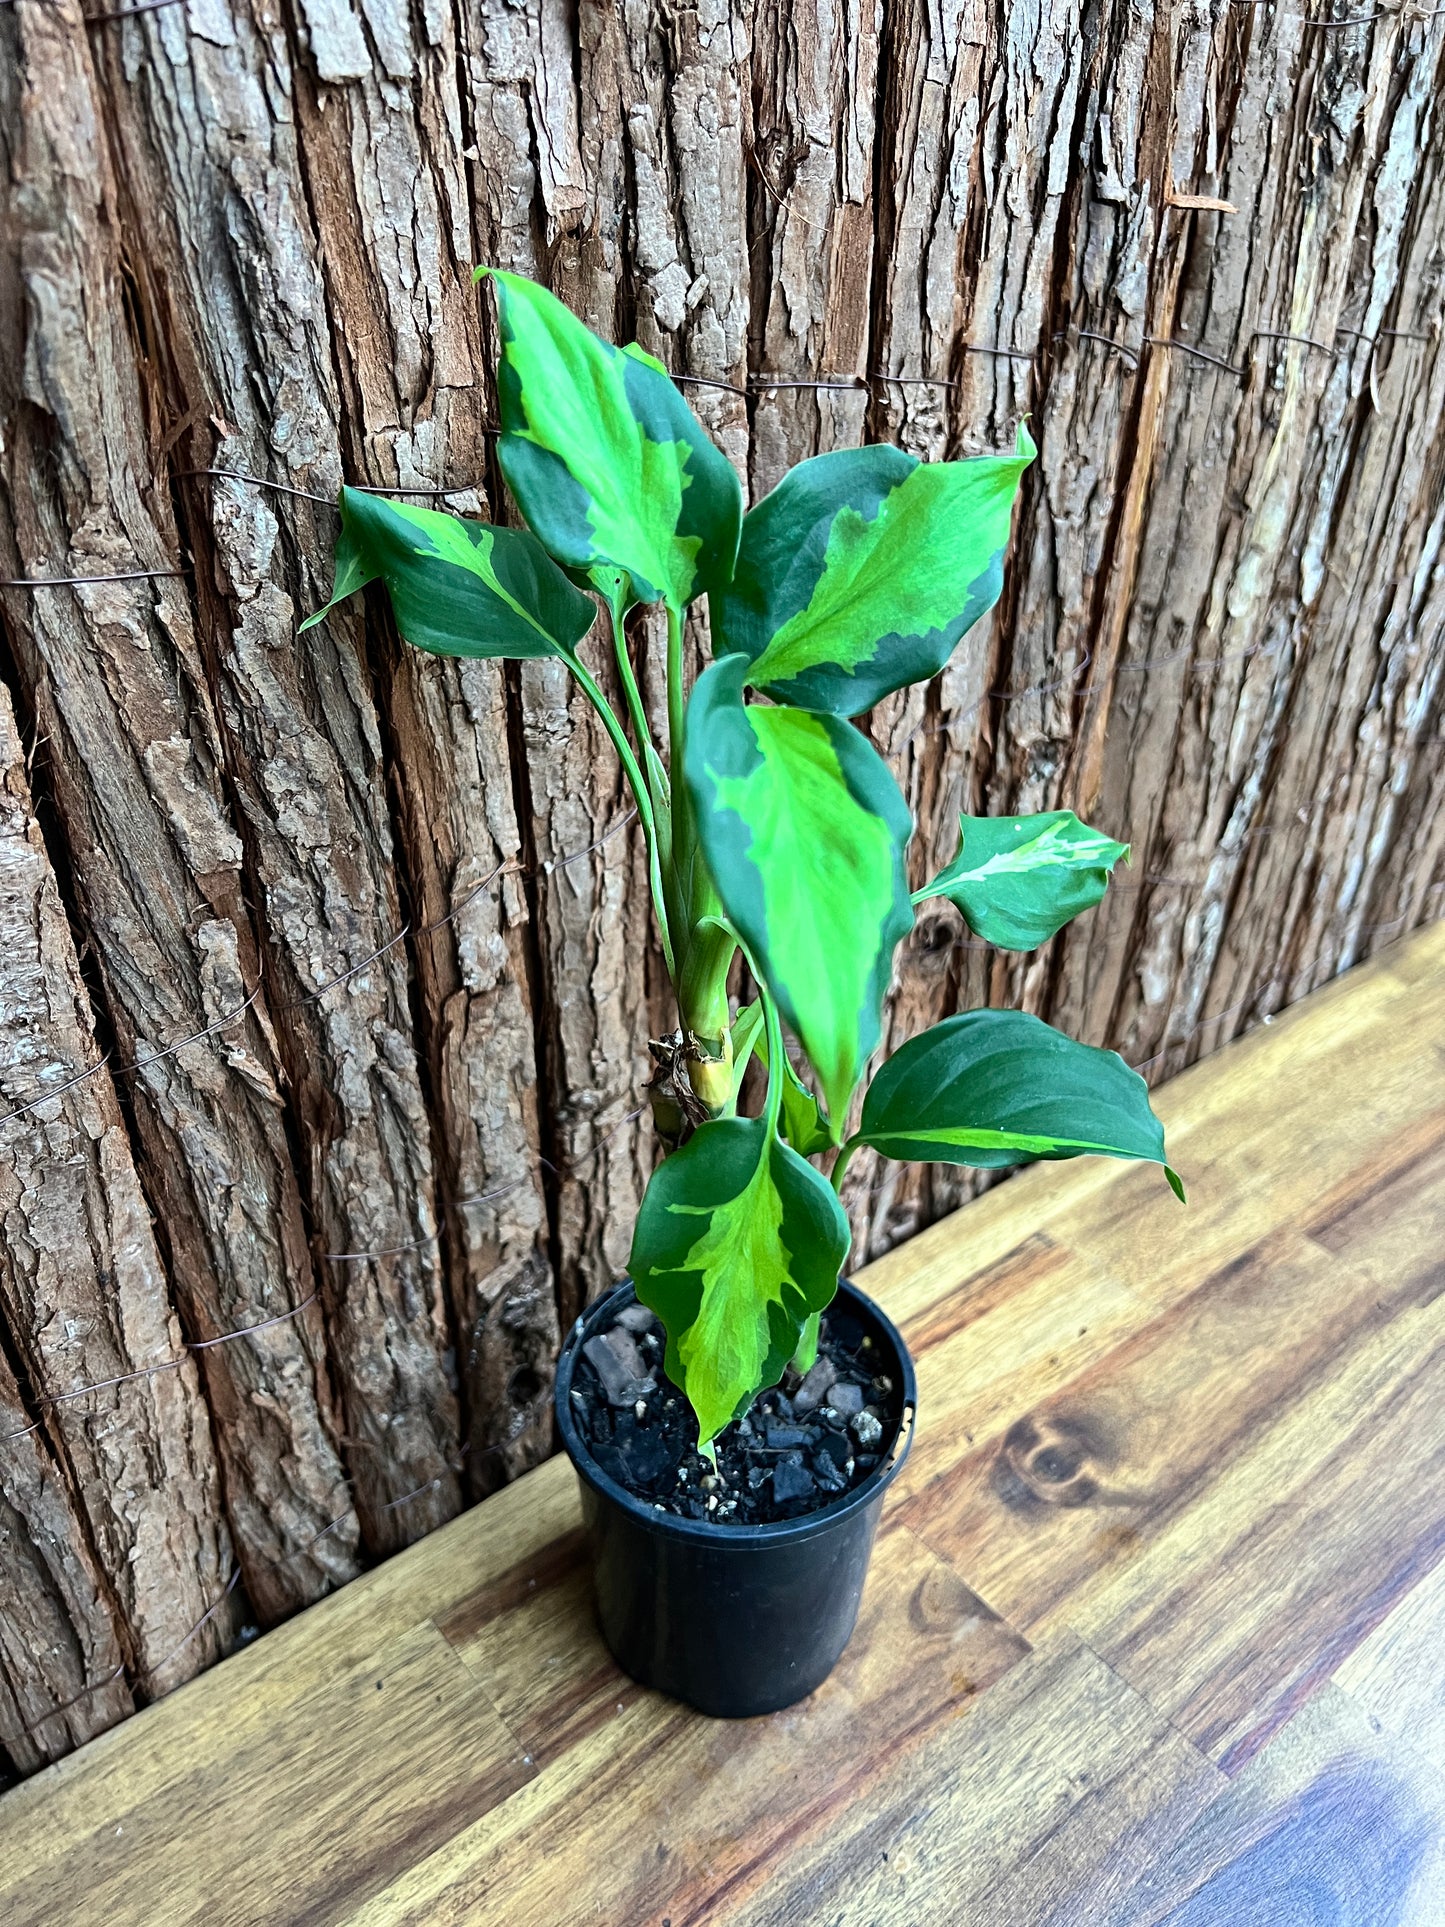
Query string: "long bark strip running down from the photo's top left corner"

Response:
xmin=0 ymin=0 xmax=356 ymax=1619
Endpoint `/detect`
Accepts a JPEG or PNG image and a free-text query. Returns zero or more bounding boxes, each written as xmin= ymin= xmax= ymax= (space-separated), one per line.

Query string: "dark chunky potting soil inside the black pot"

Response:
xmin=570 ymin=1305 xmax=902 ymax=1526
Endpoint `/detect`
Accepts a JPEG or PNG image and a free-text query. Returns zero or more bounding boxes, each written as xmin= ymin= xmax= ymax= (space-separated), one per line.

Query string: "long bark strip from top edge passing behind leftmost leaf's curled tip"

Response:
xmin=89 ymin=8 xmax=460 ymax=1551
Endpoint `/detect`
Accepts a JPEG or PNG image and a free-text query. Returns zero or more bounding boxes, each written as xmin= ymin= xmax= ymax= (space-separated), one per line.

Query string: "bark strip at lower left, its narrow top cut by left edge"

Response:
xmin=0 ymin=684 xmax=231 ymax=1692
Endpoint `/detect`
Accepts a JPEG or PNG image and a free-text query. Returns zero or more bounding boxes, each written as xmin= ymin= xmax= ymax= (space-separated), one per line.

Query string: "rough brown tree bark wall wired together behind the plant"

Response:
xmin=0 ymin=0 xmax=1445 ymax=1771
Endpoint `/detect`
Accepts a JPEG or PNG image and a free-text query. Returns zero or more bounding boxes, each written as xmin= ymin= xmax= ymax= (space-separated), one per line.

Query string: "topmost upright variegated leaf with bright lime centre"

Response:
xmin=478 ymin=270 xmax=742 ymax=611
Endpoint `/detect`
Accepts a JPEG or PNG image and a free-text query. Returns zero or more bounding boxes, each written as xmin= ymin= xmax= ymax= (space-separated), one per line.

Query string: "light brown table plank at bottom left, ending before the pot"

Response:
xmin=6 ymin=1624 xmax=530 ymax=1927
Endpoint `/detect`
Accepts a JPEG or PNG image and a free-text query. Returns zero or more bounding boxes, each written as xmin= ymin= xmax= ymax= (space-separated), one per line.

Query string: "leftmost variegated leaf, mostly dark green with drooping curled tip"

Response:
xmin=301 ymin=488 xmax=597 ymax=659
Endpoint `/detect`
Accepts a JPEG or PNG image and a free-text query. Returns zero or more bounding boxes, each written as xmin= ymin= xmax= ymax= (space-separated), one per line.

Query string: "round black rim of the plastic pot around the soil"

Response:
xmin=553 ymin=1278 xmax=919 ymax=1551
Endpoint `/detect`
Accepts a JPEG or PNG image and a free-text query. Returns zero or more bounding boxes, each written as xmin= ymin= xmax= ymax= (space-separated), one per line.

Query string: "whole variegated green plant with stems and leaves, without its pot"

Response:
xmin=310 ymin=270 xmax=1183 ymax=1451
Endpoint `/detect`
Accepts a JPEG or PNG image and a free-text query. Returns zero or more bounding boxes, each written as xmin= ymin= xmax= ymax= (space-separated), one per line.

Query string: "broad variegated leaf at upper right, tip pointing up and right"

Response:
xmin=713 ymin=426 xmax=1037 ymax=717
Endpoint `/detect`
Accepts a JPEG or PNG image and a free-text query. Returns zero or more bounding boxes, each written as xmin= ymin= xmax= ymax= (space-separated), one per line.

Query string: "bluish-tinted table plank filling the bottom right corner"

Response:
xmin=1096 ymin=1686 xmax=1445 ymax=1927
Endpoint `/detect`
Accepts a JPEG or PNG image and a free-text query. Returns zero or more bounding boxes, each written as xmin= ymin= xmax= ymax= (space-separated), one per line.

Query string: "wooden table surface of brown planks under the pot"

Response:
xmin=0 ymin=925 xmax=1445 ymax=1927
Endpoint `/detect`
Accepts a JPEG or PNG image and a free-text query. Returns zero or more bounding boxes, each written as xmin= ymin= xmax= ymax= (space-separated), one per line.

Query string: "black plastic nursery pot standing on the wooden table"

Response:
xmin=555 ymin=1283 xmax=917 ymax=1719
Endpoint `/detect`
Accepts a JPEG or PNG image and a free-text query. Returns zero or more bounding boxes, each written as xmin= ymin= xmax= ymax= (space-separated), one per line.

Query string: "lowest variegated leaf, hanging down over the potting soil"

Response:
xmin=630 ymin=1118 xmax=848 ymax=1445
